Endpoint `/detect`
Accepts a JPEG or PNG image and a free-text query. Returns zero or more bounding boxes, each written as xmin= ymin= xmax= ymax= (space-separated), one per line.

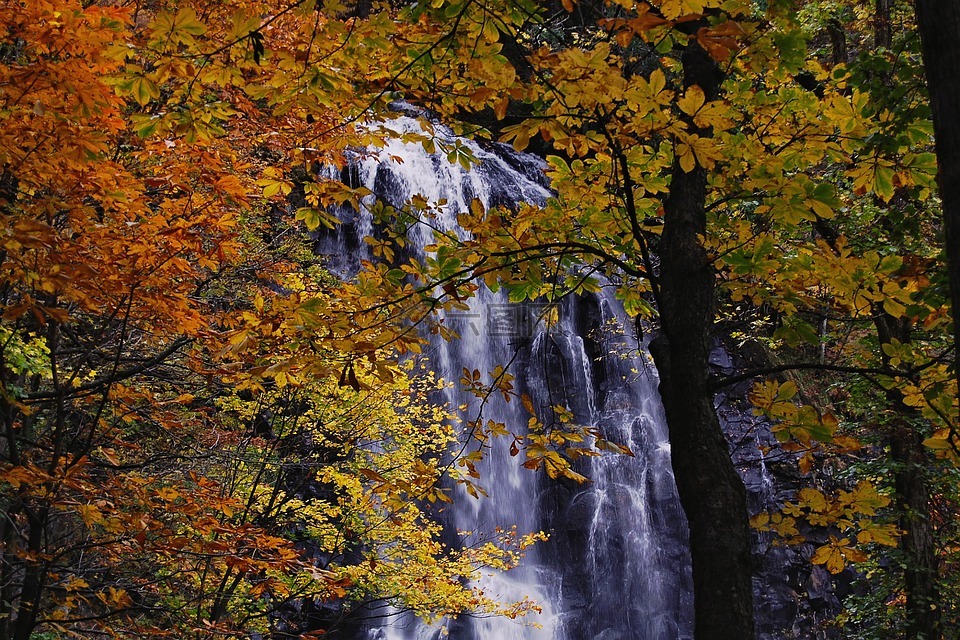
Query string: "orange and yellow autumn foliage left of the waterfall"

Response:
xmin=0 ymin=0 xmax=533 ymax=640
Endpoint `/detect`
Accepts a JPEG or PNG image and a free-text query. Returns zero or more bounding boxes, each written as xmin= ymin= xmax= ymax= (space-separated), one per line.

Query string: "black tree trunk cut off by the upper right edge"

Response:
xmin=915 ymin=0 xmax=960 ymax=404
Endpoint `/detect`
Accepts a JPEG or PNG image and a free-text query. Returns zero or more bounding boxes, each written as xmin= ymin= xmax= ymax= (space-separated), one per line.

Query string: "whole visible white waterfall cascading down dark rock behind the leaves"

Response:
xmin=318 ymin=116 xmax=692 ymax=640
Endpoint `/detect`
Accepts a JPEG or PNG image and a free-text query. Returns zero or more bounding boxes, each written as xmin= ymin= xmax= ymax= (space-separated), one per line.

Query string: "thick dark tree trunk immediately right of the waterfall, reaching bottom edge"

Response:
xmin=651 ymin=32 xmax=754 ymax=640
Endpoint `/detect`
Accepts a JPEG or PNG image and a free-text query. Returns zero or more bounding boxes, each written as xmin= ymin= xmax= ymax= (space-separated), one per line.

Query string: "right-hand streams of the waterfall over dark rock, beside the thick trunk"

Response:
xmin=526 ymin=289 xmax=692 ymax=640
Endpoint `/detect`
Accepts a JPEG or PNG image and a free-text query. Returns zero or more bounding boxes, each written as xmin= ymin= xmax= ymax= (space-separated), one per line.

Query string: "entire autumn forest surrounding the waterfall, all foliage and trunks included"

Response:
xmin=0 ymin=0 xmax=960 ymax=640
